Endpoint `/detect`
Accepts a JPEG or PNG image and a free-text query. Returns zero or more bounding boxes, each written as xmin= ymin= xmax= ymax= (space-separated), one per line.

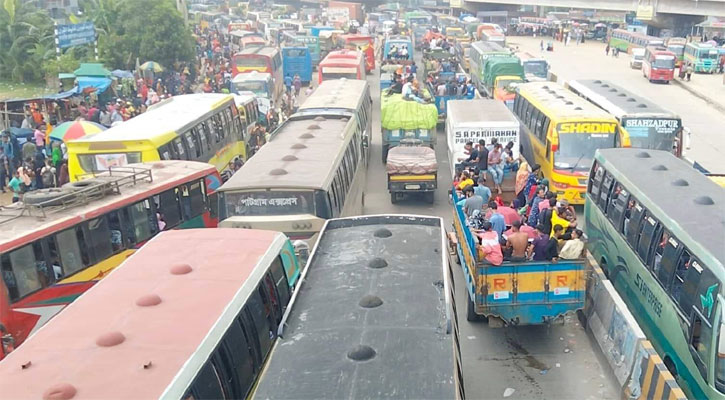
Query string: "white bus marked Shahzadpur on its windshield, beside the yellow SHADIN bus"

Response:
xmin=567 ymin=79 xmax=684 ymax=157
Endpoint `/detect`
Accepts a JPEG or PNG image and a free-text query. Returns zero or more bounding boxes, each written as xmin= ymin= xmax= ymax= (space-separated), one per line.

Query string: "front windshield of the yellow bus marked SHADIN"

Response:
xmin=554 ymin=133 xmax=616 ymax=172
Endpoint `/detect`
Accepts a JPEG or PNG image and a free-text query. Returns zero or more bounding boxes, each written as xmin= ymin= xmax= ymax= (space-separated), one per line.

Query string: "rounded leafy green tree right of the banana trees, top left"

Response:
xmin=93 ymin=0 xmax=194 ymax=69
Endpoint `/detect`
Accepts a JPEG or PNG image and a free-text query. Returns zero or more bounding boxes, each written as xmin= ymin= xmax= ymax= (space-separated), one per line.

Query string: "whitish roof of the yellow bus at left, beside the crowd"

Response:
xmin=68 ymin=93 xmax=234 ymax=148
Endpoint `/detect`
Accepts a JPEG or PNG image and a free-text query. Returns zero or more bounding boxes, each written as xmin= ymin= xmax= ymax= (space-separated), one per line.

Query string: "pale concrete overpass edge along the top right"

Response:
xmin=465 ymin=0 xmax=725 ymax=17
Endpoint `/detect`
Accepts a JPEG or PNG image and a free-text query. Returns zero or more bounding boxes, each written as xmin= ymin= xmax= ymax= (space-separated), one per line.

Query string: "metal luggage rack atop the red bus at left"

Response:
xmin=0 ymin=166 xmax=153 ymax=225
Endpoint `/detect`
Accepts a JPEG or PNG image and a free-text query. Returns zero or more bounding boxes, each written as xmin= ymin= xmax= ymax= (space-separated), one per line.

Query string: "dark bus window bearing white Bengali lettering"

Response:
xmin=224 ymin=191 xmax=315 ymax=217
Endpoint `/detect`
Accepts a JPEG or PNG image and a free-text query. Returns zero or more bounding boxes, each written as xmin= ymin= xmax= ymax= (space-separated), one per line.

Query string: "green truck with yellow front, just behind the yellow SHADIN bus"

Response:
xmin=478 ymin=56 xmax=525 ymax=108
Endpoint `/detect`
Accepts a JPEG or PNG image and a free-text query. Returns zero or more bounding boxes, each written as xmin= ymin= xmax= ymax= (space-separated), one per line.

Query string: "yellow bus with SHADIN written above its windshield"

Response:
xmin=514 ymin=82 xmax=630 ymax=204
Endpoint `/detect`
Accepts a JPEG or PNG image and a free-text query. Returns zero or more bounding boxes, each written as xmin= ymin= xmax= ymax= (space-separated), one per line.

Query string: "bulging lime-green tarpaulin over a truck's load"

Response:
xmin=380 ymin=91 xmax=438 ymax=129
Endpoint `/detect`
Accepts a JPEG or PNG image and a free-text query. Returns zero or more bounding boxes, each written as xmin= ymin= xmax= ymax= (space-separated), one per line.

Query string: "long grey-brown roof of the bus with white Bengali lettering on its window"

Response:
xmin=219 ymin=115 xmax=354 ymax=192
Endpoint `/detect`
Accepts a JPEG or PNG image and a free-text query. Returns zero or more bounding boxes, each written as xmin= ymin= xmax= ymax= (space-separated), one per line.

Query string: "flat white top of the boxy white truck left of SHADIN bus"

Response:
xmin=447 ymin=99 xmax=519 ymax=127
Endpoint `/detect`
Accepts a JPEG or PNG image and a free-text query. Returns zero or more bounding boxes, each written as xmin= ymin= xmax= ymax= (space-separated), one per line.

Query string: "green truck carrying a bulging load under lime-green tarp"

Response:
xmin=380 ymin=89 xmax=438 ymax=163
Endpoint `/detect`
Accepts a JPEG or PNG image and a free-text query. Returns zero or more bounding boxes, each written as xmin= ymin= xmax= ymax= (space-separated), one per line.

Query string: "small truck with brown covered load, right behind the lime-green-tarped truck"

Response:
xmin=385 ymin=139 xmax=438 ymax=204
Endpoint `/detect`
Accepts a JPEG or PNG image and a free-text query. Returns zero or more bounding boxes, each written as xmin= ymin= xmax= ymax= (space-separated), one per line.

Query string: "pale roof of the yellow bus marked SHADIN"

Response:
xmin=517 ymin=82 xmax=614 ymax=121
